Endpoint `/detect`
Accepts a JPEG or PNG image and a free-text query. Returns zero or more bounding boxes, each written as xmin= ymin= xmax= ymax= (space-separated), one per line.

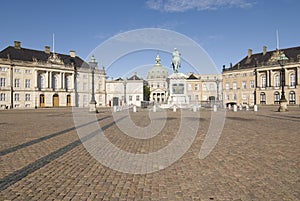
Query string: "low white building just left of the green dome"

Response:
xmin=106 ymin=73 xmax=144 ymax=107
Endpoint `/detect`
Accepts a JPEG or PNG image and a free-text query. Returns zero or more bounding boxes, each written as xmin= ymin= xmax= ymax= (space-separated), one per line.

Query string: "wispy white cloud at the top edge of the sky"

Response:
xmin=146 ymin=0 xmax=254 ymax=12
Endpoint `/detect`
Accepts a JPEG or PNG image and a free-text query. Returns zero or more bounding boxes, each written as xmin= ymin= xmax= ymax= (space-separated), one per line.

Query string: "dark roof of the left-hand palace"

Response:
xmin=0 ymin=46 xmax=88 ymax=67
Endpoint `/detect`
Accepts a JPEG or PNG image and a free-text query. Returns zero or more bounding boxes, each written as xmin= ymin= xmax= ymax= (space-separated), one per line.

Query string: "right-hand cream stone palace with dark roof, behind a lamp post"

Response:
xmin=222 ymin=46 xmax=300 ymax=105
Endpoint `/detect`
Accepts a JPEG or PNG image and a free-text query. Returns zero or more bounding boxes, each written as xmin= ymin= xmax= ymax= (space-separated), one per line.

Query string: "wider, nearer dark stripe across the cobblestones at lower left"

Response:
xmin=0 ymin=116 xmax=127 ymax=191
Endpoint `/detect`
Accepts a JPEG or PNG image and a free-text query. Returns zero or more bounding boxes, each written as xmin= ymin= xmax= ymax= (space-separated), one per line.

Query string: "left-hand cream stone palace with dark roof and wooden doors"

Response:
xmin=0 ymin=41 xmax=106 ymax=108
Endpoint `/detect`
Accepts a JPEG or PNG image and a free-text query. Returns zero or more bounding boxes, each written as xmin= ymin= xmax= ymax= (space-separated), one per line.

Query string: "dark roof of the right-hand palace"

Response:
xmin=223 ymin=46 xmax=300 ymax=71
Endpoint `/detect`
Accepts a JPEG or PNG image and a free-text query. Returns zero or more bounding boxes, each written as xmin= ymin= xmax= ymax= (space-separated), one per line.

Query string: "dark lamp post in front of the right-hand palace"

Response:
xmin=278 ymin=53 xmax=289 ymax=112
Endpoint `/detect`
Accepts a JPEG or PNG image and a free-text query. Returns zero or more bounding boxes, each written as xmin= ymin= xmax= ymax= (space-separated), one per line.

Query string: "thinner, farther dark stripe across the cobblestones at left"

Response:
xmin=0 ymin=116 xmax=109 ymax=156
